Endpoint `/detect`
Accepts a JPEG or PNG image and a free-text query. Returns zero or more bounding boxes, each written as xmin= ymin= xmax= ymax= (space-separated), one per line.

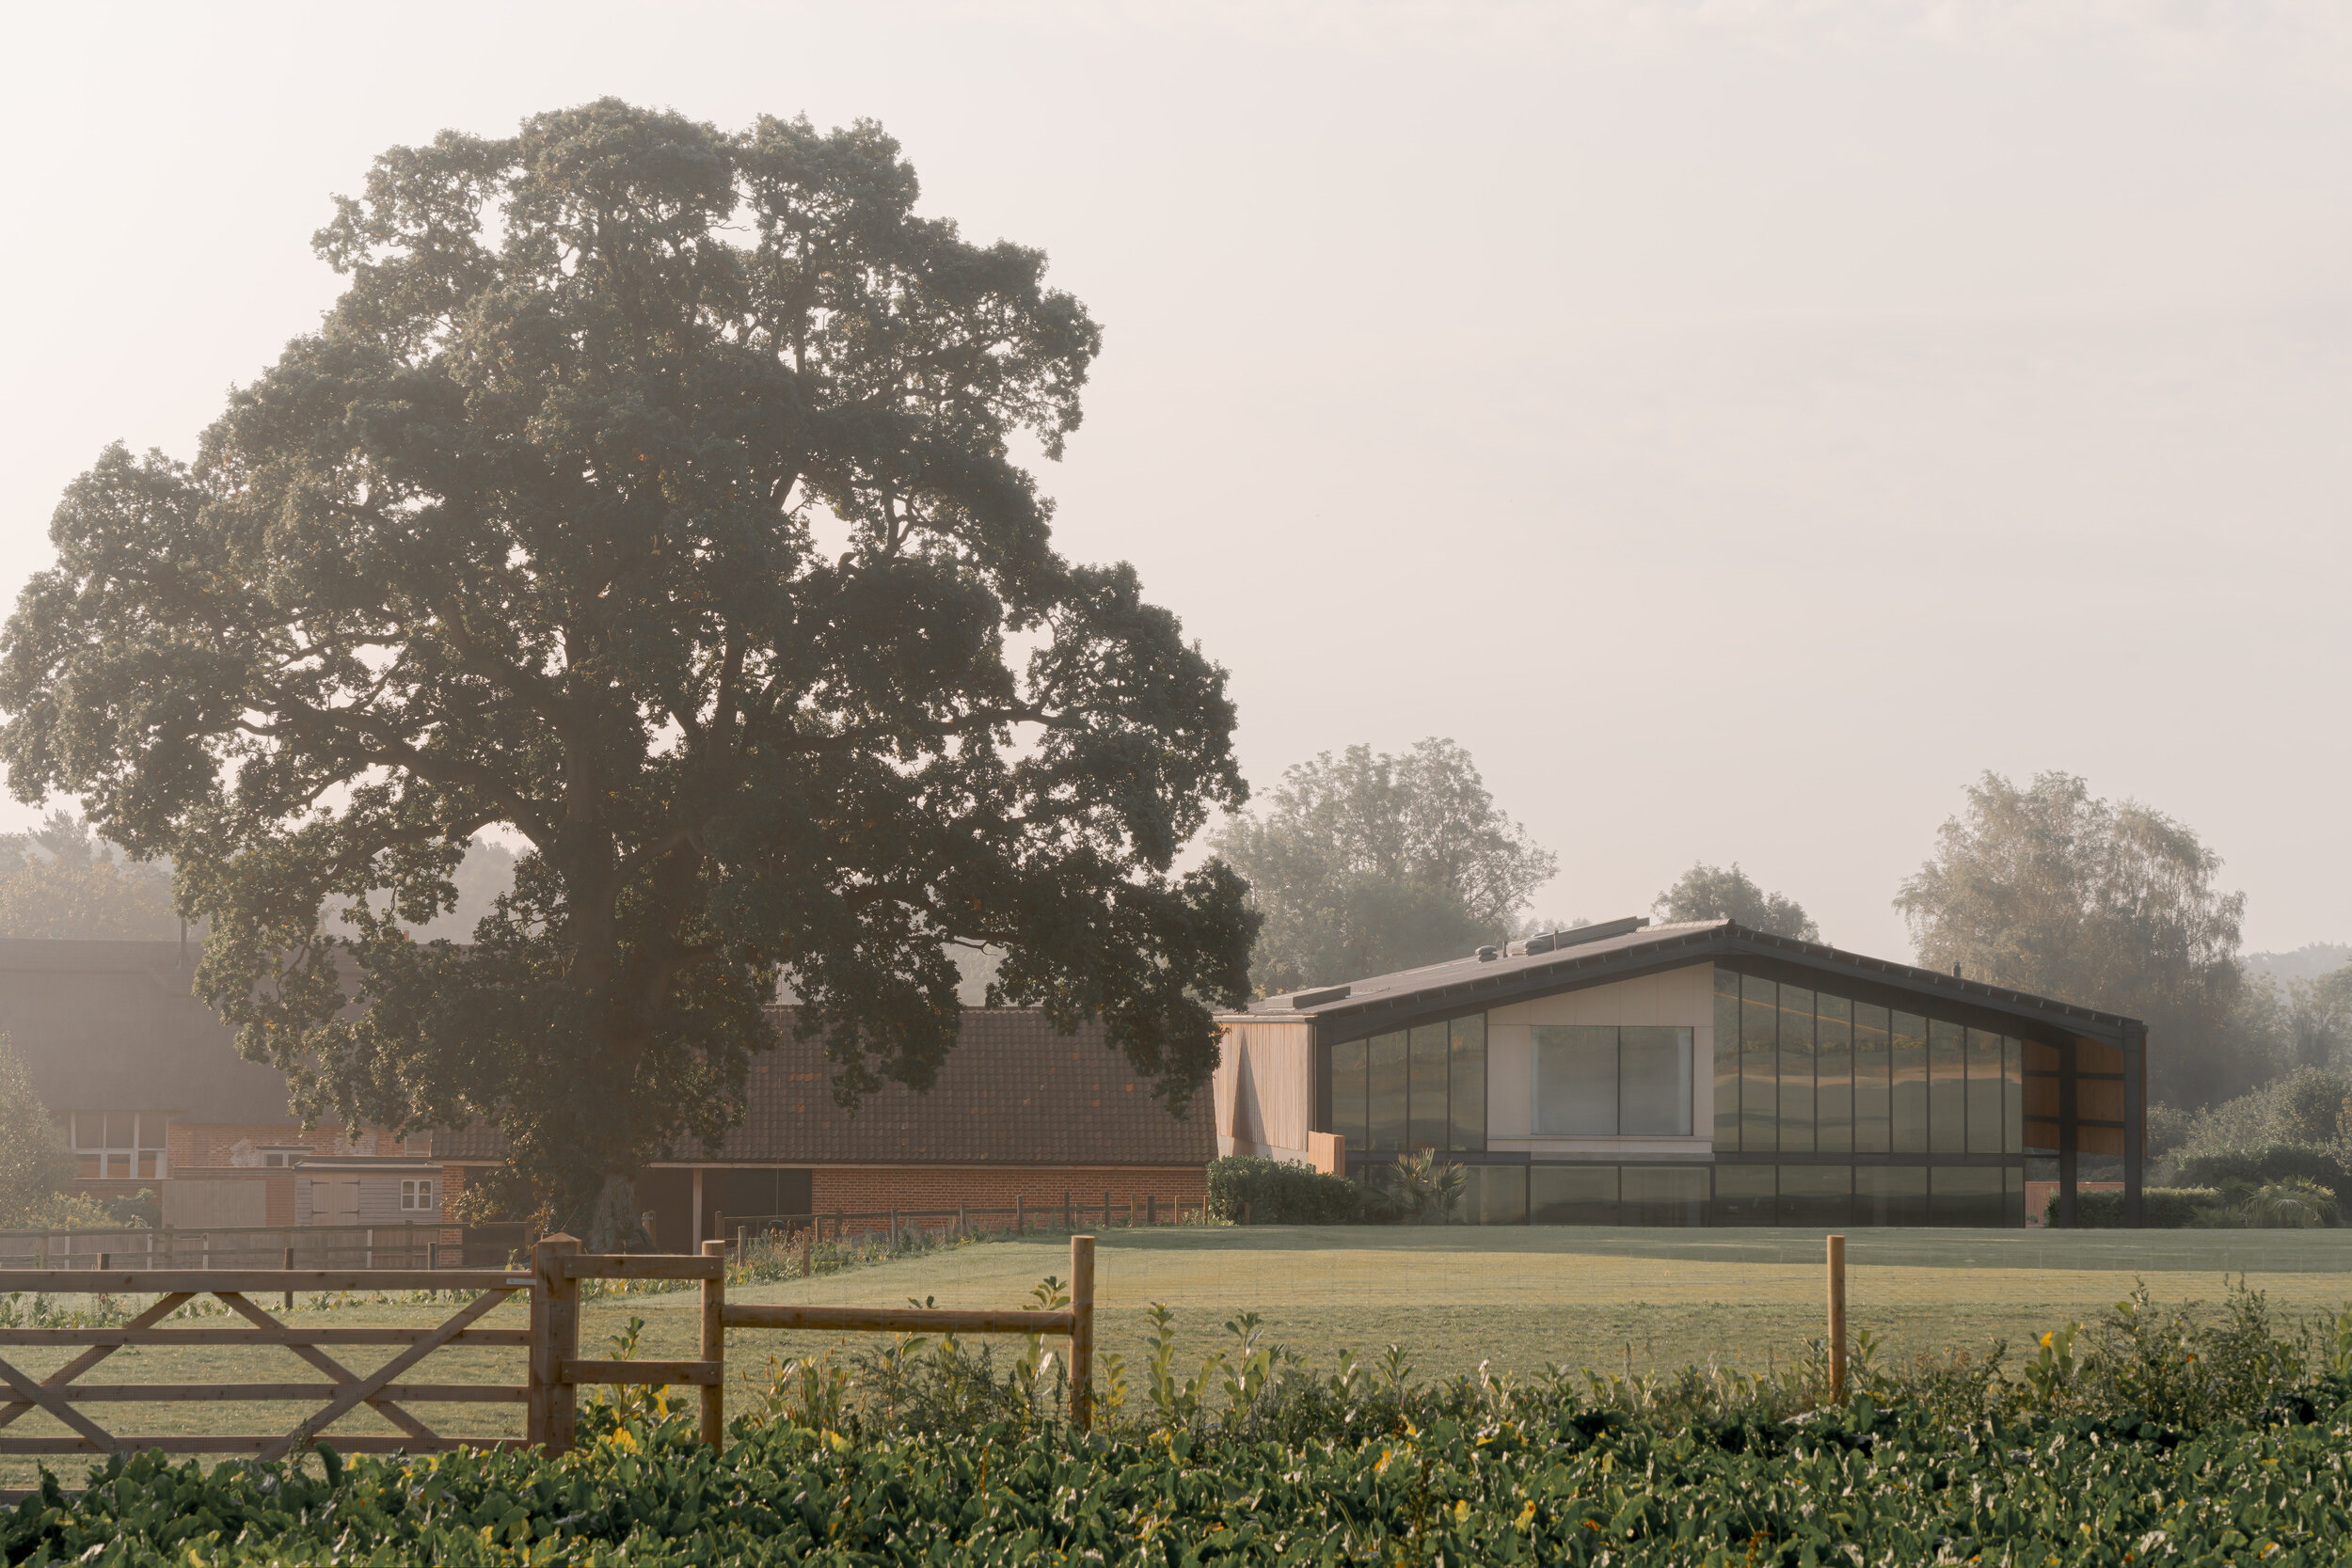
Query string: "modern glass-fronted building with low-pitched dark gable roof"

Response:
xmin=1216 ymin=919 xmax=2148 ymax=1227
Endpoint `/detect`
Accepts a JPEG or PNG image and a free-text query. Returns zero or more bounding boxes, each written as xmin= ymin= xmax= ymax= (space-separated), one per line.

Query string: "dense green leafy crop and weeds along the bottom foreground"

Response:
xmin=0 ymin=1291 xmax=2352 ymax=1568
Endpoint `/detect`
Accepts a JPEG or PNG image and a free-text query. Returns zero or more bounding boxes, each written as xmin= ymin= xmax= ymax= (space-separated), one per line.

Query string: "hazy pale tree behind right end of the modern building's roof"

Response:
xmin=1896 ymin=773 xmax=2239 ymax=1105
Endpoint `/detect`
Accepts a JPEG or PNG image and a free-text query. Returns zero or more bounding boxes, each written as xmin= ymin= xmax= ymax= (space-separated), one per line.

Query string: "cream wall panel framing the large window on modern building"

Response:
xmin=1486 ymin=964 xmax=1715 ymax=1154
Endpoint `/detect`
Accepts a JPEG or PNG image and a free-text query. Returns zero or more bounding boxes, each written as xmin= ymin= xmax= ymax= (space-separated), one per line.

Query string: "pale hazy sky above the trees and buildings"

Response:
xmin=0 ymin=0 xmax=2352 ymax=957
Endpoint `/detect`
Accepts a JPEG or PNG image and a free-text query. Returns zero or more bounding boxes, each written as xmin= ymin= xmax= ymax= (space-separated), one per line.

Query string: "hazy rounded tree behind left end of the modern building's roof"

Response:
xmin=1209 ymin=738 xmax=1560 ymax=994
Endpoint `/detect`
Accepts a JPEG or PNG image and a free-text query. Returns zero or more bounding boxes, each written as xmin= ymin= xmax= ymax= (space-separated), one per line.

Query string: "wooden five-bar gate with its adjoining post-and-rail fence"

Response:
xmin=0 ymin=1237 xmax=1094 ymax=1460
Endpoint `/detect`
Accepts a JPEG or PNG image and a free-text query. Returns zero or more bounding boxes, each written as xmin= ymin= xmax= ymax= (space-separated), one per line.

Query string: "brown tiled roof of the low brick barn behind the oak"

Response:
xmin=433 ymin=1008 xmax=1216 ymax=1166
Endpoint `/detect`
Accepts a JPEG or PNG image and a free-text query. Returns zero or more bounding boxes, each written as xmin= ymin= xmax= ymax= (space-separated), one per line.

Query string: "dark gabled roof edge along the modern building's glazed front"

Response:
xmin=1312 ymin=924 xmax=2145 ymax=1046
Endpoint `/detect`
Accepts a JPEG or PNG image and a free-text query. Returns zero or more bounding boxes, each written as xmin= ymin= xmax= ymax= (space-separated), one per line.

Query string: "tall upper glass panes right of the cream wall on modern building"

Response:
xmin=1715 ymin=969 xmax=2026 ymax=1157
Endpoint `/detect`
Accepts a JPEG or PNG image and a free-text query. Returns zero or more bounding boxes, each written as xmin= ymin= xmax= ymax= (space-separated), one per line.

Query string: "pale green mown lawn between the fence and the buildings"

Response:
xmin=0 ymin=1227 xmax=2352 ymax=1486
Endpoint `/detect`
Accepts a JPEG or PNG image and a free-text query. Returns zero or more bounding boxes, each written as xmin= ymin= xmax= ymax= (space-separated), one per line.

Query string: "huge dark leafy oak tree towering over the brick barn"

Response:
xmin=0 ymin=101 xmax=1251 ymax=1246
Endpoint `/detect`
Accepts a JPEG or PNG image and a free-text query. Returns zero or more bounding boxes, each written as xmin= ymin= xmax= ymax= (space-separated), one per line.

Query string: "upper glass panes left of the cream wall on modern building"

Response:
xmin=1331 ymin=1013 xmax=1486 ymax=1152
